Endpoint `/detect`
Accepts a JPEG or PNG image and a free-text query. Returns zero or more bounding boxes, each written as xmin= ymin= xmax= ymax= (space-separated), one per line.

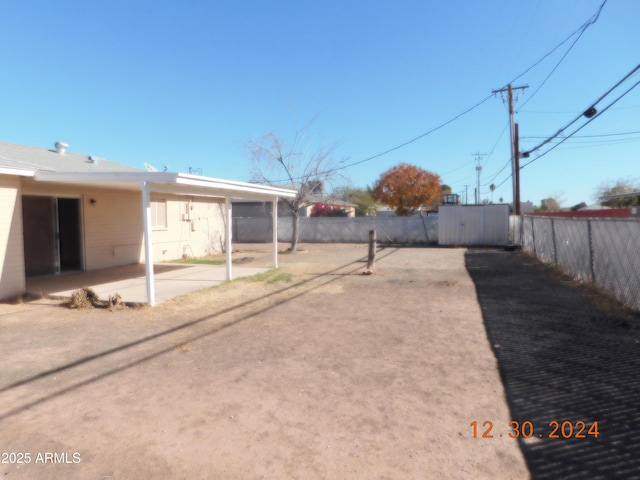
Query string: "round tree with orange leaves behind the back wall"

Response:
xmin=369 ymin=163 xmax=441 ymax=217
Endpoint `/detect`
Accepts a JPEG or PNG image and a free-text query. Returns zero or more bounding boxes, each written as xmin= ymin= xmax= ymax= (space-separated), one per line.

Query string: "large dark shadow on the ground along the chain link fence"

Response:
xmin=466 ymin=250 xmax=640 ymax=479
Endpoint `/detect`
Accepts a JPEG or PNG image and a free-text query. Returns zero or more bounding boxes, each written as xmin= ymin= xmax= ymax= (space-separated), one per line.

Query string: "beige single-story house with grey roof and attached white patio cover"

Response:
xmin=0 ymin=142 xmax=295 ymax=304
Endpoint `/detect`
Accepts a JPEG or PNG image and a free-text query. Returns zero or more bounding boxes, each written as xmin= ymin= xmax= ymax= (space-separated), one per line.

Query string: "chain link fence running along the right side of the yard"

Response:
xmin=511 ymin=215 xmax=640 ymax=311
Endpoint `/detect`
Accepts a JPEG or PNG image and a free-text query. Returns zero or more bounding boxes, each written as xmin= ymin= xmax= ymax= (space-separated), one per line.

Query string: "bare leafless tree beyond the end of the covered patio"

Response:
xmin=247 ymin=122 xmax=347 ymax=252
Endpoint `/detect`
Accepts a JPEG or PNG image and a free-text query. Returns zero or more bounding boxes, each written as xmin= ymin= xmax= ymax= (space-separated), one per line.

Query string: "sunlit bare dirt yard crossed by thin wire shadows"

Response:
xmin=0 ymin=245 xmax=529 ymax=479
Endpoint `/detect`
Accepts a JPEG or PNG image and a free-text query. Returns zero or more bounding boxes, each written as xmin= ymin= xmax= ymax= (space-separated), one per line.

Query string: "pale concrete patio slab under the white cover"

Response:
xmin=27 ymin=264 xmax=268 ymax=303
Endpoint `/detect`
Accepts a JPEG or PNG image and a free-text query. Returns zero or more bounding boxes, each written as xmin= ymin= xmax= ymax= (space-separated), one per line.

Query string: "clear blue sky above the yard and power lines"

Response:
xmin=0 ymin=0 xmax=640 ymax=206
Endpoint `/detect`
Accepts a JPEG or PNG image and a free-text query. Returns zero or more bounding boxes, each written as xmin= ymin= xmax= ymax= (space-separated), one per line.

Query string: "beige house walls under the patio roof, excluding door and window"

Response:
xmin=0 ymin=175 xmax=225 ymax=300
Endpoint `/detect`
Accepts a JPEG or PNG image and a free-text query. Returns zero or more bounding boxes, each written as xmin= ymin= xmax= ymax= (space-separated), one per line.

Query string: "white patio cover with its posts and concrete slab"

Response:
xmin=26 ymin=171 xmax=296 ymax=305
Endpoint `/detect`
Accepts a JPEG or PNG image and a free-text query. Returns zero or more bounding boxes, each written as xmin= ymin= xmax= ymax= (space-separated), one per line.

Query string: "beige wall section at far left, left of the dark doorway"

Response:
xmin=0 ymin=175 xmax=25 ymax=299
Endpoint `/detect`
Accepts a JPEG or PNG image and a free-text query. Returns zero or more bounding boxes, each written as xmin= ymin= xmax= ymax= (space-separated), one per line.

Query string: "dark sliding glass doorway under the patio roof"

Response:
xmin=22 ymin=195 xmax=82 ymax=277
